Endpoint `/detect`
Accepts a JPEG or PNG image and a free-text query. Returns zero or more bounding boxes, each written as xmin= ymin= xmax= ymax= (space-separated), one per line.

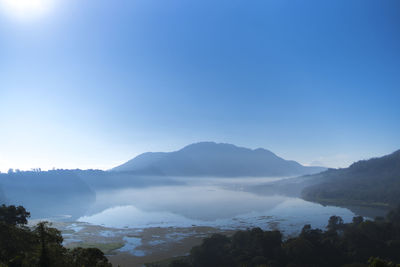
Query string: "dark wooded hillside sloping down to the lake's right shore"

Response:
xmin=302 ymin=150 xmax=400 ymax=207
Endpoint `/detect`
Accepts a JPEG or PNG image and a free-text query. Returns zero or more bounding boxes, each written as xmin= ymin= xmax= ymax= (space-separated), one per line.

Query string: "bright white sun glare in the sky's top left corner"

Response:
xmin=0 ymin=0 xmax=52 ymax=19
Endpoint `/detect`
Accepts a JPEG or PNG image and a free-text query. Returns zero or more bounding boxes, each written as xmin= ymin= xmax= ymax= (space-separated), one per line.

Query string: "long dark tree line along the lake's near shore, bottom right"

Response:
xmin=155 ymin=208 xmax=400 ymax=267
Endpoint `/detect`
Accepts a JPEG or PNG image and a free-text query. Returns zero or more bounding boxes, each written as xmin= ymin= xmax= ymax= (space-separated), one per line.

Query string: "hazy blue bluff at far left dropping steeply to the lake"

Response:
xmin=0 ymin=170 xmax=96 ymax=218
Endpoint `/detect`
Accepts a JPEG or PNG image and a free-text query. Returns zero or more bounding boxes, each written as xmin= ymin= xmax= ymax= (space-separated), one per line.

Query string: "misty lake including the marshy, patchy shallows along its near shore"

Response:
xmin=34 ymin=177 xmax=366 ymax=266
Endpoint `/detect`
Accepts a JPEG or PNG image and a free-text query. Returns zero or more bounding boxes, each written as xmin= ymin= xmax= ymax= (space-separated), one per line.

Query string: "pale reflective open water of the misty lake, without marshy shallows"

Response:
xmin=78 ymin=177 xmax=354 ymax=232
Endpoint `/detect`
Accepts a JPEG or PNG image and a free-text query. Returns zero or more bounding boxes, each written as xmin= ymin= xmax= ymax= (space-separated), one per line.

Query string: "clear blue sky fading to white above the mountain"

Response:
xmin=0 ymin=0 xmax=400 ymax=171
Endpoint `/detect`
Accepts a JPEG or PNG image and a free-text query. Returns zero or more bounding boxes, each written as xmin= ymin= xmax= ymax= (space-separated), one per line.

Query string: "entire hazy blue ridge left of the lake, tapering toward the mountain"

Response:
xmin=0 ymin=169 xmax=183 ymax=220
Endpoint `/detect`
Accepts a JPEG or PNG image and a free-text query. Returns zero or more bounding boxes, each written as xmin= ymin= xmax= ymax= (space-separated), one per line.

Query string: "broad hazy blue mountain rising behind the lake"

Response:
xmin=111 ymin=142 xmax=325 ymax=177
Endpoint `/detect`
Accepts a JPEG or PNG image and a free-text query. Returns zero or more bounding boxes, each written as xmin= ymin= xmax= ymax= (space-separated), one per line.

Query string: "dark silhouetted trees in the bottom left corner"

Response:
xmin=0 ymin=205 xmax=111 ymax=267
